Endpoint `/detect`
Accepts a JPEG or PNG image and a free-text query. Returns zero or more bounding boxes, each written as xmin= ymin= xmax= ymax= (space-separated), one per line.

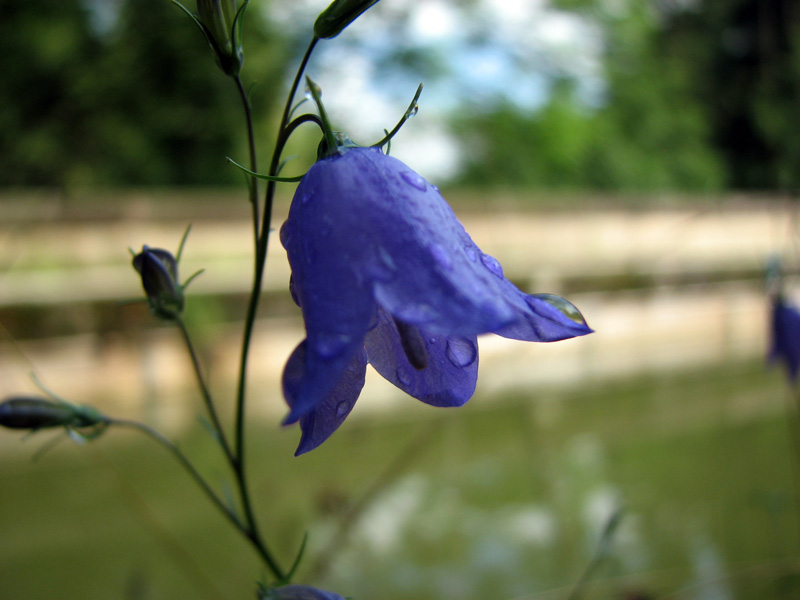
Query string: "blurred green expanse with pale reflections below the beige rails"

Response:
xmin=0 ymin=362 xmax=800 ymax=600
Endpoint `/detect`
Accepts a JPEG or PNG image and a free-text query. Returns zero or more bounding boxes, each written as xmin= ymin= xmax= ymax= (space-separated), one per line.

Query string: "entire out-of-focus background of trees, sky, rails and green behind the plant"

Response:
xmin=0 ymin=0 xmax=800 ymax=600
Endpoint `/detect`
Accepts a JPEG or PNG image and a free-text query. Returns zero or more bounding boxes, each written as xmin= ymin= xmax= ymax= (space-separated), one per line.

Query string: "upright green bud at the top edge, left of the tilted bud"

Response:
xmin=197 ymin=0 xmax=244 ymax=75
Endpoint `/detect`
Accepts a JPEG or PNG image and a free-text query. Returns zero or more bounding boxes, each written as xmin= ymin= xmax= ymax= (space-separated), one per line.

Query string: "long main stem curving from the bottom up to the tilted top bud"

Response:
xmin=231 ymin=38 xmax=318 ymax=582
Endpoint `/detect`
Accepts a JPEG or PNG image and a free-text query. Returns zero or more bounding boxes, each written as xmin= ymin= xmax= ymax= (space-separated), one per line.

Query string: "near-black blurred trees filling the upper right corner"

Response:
xmin=662 ymin=0 xmax=800 ymax=189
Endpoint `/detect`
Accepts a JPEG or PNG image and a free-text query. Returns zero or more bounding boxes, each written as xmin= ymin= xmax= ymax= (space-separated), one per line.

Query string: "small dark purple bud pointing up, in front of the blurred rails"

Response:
xmin=133 ymin=246 xmax=184 ymax=321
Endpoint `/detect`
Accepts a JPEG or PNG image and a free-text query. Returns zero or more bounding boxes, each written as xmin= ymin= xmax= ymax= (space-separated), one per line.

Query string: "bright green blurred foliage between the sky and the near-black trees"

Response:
xmin=456 ymin=1 xmax=725 ymax=190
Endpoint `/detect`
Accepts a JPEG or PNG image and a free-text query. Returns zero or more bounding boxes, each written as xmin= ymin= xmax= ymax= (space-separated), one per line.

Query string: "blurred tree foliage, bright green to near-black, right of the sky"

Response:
xmin=456 ymin=0 xmax=800 ymax=190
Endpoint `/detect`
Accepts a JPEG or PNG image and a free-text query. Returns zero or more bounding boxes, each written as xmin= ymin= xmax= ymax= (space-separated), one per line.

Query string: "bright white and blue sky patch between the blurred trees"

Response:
xmin=266 ymin=0 xmax=603 ymax=183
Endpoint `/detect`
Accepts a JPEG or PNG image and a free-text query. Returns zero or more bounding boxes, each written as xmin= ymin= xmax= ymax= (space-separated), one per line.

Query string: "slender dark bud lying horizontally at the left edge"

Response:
xmin=0 ymin=396 xmax=104 ymax=431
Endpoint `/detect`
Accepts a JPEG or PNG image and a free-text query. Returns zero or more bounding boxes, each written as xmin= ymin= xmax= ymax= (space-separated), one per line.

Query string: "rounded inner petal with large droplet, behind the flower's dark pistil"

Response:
xmin=365 ymin=309 xmax=478 ymax=406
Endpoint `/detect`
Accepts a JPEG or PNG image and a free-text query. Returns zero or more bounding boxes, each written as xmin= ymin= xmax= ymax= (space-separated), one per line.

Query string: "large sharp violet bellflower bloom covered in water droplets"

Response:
xmin=281 ymin=148 xmax=592 ymax=454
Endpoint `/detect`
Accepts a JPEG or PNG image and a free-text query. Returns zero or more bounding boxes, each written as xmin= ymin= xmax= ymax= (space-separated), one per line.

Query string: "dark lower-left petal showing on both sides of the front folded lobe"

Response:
xmin=283 ymin=341 xmax=367 ymax=456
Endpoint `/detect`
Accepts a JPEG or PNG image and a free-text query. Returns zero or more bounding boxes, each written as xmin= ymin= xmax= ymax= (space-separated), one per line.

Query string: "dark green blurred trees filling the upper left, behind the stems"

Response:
xmin=0 ymin=0 xmax=287 ymax=189
